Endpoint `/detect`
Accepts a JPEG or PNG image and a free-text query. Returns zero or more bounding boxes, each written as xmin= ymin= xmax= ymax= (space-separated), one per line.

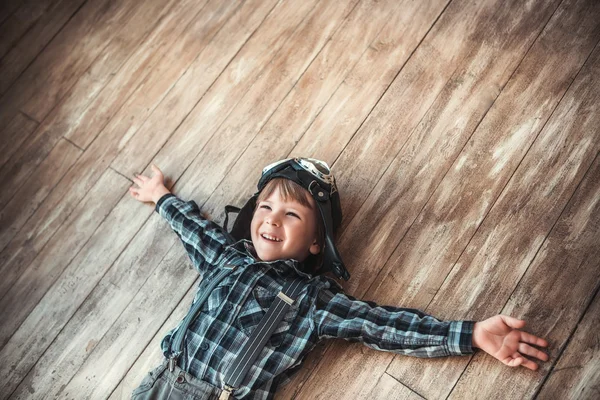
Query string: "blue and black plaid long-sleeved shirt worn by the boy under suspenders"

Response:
xmin=156 ymin=194 xmax=474 ymax=399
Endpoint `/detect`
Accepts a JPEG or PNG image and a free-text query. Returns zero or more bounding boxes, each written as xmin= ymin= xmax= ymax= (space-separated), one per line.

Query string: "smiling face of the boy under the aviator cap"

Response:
xmin=250 ymin=188 xmax=319 ymax=261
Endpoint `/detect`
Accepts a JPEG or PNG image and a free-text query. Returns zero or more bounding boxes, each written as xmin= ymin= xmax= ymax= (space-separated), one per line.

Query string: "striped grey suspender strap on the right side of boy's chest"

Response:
xmin=219 ymin=279 xmax=303 ymax=400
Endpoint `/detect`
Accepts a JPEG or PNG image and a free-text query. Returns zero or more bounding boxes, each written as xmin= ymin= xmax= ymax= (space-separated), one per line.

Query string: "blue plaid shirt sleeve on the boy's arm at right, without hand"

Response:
xmin=314 ymin=290 xmax=475 ymax=357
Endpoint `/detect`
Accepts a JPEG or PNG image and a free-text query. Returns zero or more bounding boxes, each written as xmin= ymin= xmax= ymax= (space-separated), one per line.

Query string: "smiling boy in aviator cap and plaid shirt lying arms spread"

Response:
xmin=130 ymin=158 xmax=548 ymax=399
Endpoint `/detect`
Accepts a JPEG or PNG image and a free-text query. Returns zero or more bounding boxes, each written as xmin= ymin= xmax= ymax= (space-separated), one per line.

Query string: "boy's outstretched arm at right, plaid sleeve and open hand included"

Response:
xmin=312 ymin=287 xmax=548 ymax=370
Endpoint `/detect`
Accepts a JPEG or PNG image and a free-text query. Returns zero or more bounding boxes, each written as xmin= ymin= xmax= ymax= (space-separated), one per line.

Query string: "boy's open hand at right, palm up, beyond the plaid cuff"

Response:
xmin=473 ymin=315 xmax=548 ymax=371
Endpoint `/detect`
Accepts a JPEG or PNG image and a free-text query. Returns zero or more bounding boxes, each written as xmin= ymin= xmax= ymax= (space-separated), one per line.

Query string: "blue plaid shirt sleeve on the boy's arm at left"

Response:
xmin=155 ymin=193 xmax=233 ymax=274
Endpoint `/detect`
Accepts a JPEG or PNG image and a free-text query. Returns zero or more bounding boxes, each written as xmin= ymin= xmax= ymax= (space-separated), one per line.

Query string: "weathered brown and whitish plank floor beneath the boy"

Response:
xmin=0 ymin=0 xmax=600 ymax=399
